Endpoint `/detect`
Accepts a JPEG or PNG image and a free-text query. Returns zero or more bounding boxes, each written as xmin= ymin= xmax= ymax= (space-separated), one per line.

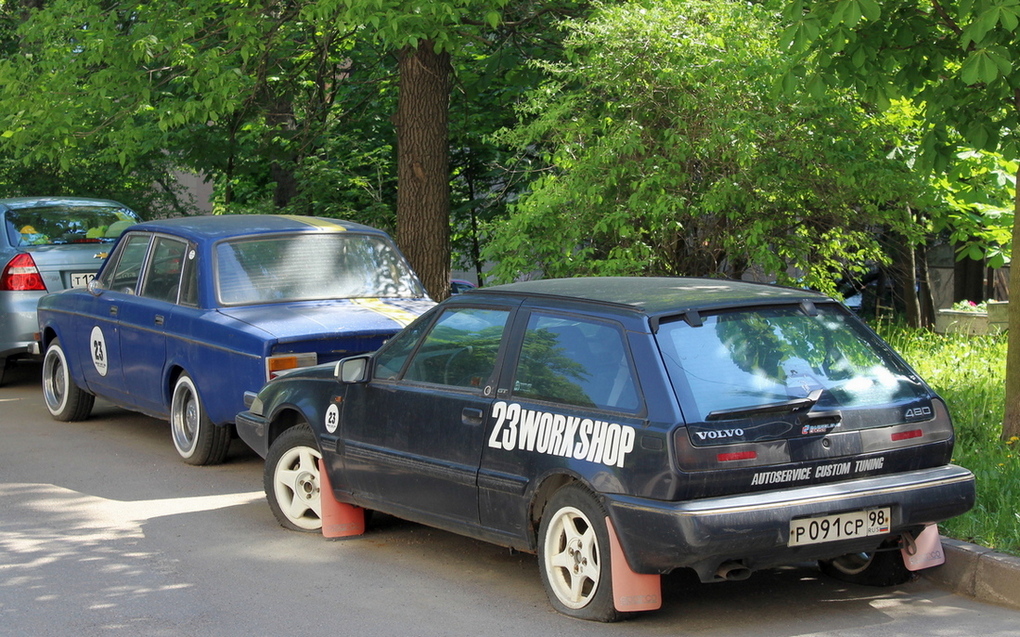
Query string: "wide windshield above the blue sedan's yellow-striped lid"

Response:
xmin=216 ymin=232 xmax=425 ymax=305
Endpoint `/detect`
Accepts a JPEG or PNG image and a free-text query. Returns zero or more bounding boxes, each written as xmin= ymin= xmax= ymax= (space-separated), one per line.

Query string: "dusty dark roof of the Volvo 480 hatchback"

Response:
xmin=466 ymin=276 xmax=829 ymax=317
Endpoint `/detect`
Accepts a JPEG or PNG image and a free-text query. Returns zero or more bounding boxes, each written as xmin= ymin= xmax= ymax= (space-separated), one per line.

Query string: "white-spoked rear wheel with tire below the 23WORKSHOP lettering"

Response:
xmin=539 ymin=484 xmax=622 ymax=622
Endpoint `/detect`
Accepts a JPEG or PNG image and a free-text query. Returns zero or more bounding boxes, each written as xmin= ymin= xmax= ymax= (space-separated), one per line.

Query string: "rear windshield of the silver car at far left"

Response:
xmin=4 ymin=205 xmax=137 ymax=246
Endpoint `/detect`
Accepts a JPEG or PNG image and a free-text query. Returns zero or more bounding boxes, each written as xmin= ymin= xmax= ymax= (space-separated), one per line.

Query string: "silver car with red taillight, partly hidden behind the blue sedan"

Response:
xmin=0 ymin=197 xmax=139 ymax=383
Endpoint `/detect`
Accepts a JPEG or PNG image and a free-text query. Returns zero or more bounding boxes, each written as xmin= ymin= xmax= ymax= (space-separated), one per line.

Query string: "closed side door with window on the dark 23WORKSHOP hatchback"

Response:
xmin=342 ymin=307 xmax=510 ymax=524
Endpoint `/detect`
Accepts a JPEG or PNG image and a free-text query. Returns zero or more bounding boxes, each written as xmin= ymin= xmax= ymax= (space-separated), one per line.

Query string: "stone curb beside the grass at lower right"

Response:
xmin=921 ymin=536 xmax=1020 ymax=611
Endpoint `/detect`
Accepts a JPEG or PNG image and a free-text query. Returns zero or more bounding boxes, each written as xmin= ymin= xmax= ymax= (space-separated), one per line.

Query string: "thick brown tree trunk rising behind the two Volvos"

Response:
xmin=394 ymin=41 xmax=452 ymax=301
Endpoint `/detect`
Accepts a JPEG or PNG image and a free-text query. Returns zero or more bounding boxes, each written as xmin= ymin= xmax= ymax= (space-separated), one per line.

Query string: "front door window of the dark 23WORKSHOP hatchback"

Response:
xmin=404 ymin=308 xmax=510 ymax=387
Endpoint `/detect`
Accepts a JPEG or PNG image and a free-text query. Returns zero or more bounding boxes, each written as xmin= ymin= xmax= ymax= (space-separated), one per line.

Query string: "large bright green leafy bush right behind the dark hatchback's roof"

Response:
xmin=486 ymin=1 xmax=923 ymax=288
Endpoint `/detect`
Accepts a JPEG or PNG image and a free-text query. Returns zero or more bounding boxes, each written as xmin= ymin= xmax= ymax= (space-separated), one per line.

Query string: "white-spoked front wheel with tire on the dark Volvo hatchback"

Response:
xmin=262 ymin=423 xmax=322 ymax=533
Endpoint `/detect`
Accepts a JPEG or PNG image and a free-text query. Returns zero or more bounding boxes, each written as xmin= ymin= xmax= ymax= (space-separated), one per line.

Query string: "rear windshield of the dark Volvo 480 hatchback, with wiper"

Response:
xmin=657 ymin=306 xmax=929 ymax=422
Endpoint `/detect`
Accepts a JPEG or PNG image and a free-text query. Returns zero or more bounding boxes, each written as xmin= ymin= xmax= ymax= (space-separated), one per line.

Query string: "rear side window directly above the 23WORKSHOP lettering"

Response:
xmin=513 ymin=313 xmax=640 ymax=412
